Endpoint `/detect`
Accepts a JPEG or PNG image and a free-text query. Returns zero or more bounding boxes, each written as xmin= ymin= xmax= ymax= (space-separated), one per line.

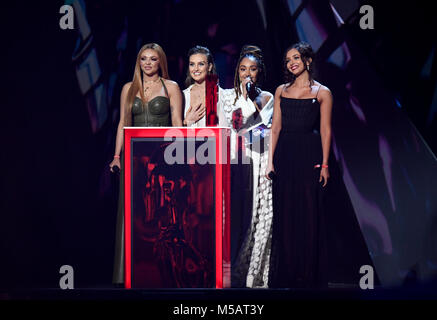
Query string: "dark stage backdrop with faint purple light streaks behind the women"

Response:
xmin=0 ymin=0 xmax=437 ymax=297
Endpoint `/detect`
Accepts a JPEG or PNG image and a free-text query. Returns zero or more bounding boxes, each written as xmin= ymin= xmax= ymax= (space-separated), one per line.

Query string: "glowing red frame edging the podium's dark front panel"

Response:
xmin=124 ymin=127 xmax=230 ymax=289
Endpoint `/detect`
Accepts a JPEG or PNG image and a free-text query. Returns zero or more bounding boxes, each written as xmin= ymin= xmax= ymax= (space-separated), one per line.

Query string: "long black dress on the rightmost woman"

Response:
xmin=269 ymin=97 xmax=327 ymax=288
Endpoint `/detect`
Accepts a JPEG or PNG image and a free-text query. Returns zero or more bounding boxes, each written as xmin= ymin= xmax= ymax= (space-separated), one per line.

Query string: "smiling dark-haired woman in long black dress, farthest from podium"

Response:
xmin=266 ymin=42 xmax=332 ymax=288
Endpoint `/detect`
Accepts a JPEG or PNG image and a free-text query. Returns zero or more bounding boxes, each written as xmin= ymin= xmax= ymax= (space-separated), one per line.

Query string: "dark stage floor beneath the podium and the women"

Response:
xmin=5 ymin=283 xmax=437 ymax=303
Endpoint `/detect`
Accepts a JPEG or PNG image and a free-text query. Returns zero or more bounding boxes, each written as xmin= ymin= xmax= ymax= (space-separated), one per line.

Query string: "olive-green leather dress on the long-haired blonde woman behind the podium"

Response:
xmin=112 ymin=79 xmax=171 ymax=284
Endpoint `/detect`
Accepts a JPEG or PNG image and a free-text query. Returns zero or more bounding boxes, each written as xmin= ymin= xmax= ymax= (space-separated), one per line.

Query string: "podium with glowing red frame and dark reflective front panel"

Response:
xmin=124 ymin=127 xmax=230 ymax=288
